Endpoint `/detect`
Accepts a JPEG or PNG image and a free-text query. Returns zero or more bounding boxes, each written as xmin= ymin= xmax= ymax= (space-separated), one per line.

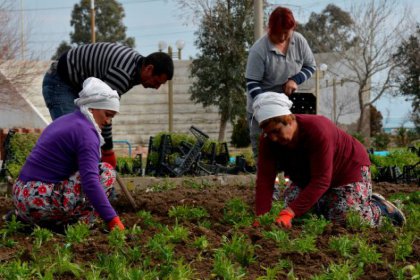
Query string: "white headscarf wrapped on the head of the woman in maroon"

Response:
xmin=252 ymin=91 xmax=293 ymax=124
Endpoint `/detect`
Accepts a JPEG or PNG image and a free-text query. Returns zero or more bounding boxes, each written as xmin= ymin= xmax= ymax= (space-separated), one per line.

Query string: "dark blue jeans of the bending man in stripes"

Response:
xmin=42 ymin=65 xmax=78 ymax=120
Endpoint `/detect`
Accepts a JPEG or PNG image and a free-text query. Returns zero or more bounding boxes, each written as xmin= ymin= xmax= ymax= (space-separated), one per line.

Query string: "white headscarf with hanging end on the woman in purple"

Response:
xmin=74 ymin=77 xmax=120 ymax=149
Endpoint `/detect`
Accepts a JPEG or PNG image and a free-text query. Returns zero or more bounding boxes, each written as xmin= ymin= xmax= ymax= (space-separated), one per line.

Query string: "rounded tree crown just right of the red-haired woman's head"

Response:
xmin=297 ymin=4 xmax=356 ymax=53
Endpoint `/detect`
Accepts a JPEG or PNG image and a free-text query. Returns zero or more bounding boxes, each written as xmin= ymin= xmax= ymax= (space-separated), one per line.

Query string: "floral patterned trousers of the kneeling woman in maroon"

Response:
xmin=284 ymin=166 xmax=381 ymax=226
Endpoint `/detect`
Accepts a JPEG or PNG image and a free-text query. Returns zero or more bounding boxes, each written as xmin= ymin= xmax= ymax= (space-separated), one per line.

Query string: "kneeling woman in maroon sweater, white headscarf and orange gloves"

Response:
xmin=253 ymin=92 xmax=405 ymax=228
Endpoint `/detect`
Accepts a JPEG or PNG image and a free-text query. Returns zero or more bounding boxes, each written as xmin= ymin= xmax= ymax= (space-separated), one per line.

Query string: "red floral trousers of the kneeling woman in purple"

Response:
xmin=13 ymin=162 xmax=116 ymax=227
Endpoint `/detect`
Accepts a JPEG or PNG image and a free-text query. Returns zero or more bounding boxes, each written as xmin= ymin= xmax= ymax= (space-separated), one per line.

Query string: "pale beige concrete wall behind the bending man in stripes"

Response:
xmin=0 ymin=60 xmax=232 ymax=151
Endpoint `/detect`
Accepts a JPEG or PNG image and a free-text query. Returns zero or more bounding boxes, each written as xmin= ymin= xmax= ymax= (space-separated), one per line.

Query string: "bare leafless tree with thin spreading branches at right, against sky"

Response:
xmin=341 ymin=0 xmax=413 ymax=132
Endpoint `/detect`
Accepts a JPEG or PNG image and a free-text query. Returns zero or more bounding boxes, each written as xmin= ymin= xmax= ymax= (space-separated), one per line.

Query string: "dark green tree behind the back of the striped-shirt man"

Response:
xmin=53 ymin=0 xmax=135 ymax=58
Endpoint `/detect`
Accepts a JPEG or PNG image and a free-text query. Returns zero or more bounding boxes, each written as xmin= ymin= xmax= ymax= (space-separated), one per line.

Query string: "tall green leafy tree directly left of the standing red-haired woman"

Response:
xmin=189 ymin=0 xmax=253 ymax=141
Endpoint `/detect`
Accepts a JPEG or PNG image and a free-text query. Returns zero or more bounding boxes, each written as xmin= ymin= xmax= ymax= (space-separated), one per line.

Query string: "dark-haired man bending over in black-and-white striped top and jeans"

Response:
xmin=42 ymin=43 xmax=174 ymax=167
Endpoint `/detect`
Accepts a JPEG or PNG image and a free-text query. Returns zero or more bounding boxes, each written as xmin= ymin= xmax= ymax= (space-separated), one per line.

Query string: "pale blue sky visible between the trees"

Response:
xmin=11 ymin=0 xmax=420 ymax=127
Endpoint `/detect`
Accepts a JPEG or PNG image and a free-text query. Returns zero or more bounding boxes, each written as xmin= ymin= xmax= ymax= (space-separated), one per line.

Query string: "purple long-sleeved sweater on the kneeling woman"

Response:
xmin=19 ymin=110 xmax=117 ymax=222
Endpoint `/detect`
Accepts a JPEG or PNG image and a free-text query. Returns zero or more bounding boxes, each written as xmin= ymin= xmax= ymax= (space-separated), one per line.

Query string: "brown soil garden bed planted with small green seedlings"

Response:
xmin=0 ymin=181 xmax=420 ymax=279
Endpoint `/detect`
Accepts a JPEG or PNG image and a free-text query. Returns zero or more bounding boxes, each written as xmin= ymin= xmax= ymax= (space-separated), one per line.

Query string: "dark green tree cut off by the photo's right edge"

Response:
xmin=395 ymin=23 xmax=420 ymax=133
